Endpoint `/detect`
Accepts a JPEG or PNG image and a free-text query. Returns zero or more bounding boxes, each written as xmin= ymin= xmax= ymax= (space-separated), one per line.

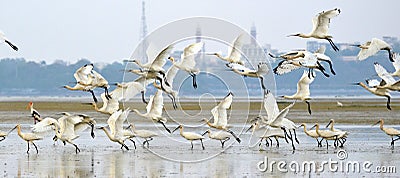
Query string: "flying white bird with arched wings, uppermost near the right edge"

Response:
xmin=352 ymin=38 xmax=394 ymax=62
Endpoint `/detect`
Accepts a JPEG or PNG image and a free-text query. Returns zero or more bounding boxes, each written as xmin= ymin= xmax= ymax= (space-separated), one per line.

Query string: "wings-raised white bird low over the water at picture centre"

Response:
xmin=203 ymin=92 xmax=240 ymax=143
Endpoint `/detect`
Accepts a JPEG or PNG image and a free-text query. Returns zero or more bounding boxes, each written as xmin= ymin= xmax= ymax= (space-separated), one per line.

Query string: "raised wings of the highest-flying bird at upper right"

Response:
xmin=311 ymin=8 xmax=340 ymax=35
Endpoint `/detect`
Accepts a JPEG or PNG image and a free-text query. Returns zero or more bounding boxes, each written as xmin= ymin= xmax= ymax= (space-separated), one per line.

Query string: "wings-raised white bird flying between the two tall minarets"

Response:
xmin=208 ymin=34 xmax=244 ymax=65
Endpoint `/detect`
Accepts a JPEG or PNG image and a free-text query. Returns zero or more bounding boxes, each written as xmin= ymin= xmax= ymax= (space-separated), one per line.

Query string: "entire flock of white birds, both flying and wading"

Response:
xmin=0 ymin=8 xmax=400 ymax=153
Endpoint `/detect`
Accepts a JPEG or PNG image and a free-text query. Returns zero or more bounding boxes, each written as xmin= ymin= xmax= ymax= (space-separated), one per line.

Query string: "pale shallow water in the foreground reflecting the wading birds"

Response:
xmin=0 ymin=124 xmax=400 ymax=177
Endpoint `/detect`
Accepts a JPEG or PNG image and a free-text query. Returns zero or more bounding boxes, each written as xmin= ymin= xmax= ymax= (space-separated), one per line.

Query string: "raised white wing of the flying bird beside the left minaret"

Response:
xmin=180 ymin=42 xmax=204 ymax=69
